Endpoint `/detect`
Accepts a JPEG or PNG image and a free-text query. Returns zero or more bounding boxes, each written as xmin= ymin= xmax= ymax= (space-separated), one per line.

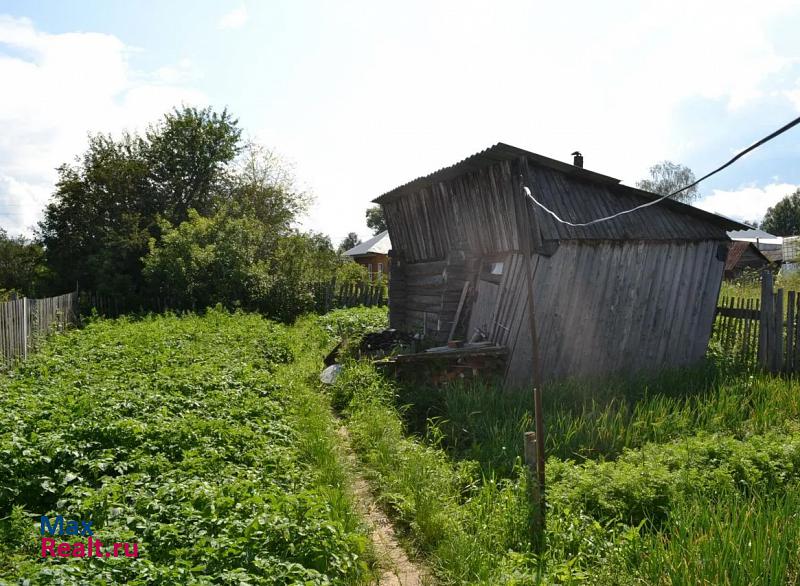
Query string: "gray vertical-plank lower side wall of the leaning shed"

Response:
xmin=504 ymin=241 xmax=724 ymax=387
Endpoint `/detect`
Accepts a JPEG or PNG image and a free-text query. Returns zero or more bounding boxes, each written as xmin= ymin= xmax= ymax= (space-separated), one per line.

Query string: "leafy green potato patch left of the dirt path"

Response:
xmin=0 ymin=310 xmax=370 ymax=584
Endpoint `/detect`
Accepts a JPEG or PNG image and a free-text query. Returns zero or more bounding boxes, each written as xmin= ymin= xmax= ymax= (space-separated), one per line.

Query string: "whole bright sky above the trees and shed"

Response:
xmin=0 ymin=0 xmax=800 ymax=241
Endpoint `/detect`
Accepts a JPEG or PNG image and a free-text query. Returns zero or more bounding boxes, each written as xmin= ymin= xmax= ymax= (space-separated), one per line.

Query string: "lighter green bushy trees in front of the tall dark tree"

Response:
xmin=143 ymin=210 xmax=343 ymax=321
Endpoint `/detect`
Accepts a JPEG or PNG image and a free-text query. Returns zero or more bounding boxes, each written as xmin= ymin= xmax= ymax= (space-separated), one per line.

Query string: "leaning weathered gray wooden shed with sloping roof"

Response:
xmin=375 ymin=143 xmax=743 ymax=387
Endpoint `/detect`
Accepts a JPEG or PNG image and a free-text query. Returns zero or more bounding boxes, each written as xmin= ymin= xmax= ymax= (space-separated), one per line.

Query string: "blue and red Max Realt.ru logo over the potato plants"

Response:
xmin=39 ymin=515 xmax=139 ymax=558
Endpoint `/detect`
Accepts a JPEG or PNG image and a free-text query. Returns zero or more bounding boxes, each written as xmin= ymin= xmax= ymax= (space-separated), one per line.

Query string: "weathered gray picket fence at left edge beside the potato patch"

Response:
xmin=0 ymin=291 xmax=79 ymax=366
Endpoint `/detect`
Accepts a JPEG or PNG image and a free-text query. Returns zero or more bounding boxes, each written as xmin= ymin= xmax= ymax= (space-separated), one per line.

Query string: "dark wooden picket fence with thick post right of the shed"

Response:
xmin=712 ymin=271 xmax=800 ymax=373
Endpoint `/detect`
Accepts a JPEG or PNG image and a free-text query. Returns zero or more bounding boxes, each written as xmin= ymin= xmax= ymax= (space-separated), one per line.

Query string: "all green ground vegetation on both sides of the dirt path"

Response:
xmin=0 ymin=308 xmax=800 ymax=585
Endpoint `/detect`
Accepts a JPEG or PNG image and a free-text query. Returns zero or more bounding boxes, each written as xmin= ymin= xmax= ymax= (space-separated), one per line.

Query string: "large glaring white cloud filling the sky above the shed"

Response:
xmin=265 ymin=0 xmax=800 ymax=240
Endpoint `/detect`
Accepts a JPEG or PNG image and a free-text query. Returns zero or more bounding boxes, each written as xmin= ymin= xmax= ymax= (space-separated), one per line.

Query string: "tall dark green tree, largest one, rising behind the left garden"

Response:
xmin=39 ymin=108 xmax=240 ymax=298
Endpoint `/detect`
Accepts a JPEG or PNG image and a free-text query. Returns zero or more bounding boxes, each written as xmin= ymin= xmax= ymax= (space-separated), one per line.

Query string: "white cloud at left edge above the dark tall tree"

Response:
xmin=0 ymin=16 xmax=207 ymax=233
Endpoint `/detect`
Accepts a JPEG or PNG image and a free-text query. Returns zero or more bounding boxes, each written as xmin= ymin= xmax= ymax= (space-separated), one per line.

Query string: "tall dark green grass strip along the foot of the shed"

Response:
xmin=395 ymin=365 xmax=800 ymax=475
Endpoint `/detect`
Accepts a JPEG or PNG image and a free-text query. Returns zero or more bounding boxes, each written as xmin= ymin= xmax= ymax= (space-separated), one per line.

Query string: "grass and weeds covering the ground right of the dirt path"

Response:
xmin=333 ymin=342 xmax=800 ymax=585
